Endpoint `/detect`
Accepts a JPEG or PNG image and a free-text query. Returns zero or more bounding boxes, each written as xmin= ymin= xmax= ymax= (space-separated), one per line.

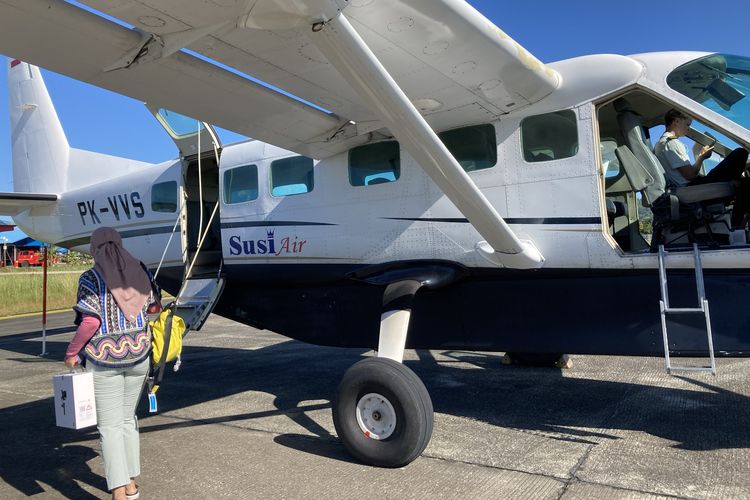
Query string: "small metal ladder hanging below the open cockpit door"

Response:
xmin=659 ymin=243 xmax=716 ymax=375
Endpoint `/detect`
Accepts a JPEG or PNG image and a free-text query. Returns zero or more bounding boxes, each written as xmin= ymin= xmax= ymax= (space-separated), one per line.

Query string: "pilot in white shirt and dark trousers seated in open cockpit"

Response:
xmin=654 ymin=109 xmax=750 ymax=228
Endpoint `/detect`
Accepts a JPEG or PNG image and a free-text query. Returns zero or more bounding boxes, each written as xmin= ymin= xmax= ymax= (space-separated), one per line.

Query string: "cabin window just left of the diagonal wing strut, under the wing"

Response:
xmin=349 ymin=141 xmax=401 ymax=186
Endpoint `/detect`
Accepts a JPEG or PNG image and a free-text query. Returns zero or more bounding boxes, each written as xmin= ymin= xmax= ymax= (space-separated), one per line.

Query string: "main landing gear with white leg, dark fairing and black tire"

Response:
xmin=333 ymin=265 xmax=463 ymax=467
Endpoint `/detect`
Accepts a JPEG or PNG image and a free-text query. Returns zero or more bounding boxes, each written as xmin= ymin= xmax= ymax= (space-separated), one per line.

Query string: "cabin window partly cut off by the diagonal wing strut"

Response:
xmin=438 ymin=124 xmax=497 ymax=172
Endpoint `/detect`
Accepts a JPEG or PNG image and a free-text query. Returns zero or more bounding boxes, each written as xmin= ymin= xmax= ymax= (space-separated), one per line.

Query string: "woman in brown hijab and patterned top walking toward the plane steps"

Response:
xmin=65 ymin=227 xmax=154 ymax=500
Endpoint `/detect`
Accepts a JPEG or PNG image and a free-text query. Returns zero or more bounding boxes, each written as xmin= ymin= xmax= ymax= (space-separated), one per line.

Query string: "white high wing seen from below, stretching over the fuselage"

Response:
xmin=0 ymin=0 xmax=558 ymax=159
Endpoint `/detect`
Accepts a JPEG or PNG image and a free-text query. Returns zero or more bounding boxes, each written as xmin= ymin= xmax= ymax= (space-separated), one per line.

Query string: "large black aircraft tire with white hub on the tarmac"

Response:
xmin=333 ymin=358 xmax=433 ymax=467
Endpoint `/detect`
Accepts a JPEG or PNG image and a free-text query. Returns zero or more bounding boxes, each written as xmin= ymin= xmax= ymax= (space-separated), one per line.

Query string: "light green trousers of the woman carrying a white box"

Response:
xmin=91 ymin=357 xmax=149 ymax=490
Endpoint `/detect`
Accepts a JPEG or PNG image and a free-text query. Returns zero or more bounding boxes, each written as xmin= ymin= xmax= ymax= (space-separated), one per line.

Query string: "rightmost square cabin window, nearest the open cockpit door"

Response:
xmin=521 ymin=109 xmax=578 ymax=163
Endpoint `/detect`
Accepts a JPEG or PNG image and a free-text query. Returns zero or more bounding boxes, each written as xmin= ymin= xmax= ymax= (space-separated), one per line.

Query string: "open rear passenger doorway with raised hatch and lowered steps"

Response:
xmin=146 ymin=104 xmax=224 ymax=330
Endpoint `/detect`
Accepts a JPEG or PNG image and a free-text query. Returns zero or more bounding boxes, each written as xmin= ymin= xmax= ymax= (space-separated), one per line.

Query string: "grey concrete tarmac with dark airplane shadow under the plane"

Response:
xmin=0 ymin=313 xmax=750 ymax=500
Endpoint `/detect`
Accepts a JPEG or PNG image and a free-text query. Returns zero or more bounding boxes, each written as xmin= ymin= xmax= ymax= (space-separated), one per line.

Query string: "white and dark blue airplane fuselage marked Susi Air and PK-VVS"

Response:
xmin=11 ymin=53 xmax=750 ymax=355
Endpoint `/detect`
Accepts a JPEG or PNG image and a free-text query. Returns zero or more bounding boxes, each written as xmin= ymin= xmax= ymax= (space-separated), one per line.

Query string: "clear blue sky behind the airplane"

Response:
xmin=0 ymin=0 xmax=750 ymax=235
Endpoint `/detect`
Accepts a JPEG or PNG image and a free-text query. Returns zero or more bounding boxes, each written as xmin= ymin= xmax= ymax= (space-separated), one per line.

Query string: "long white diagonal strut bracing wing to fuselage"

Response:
xmin=309 ymin=13 xmax=544 ymax=269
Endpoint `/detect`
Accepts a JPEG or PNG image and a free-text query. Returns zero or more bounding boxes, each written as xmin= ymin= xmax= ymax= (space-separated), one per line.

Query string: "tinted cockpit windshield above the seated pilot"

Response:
xmin=667 ymin=54 xmax=750 ymax=130
